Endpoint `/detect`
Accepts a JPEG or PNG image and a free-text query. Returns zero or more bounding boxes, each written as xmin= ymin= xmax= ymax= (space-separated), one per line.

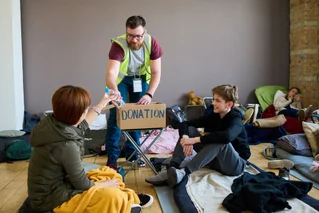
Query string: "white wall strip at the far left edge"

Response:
xmin=0 ymin=0 xmax=24 ymax=131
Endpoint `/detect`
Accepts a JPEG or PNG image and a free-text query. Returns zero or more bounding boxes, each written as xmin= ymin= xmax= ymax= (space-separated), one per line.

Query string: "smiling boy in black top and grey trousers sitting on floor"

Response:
xmin=145 ymin=85 xmax=251 ymax=187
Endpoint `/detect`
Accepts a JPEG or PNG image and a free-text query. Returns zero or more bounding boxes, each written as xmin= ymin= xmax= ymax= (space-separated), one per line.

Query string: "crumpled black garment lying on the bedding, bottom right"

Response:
xmin=223 ymin=172 xmax=312 ymax=213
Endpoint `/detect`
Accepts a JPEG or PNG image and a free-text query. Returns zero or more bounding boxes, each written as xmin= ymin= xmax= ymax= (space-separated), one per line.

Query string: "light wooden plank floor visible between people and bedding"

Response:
xmin=0 ymin=143 xmax=319 ymax=213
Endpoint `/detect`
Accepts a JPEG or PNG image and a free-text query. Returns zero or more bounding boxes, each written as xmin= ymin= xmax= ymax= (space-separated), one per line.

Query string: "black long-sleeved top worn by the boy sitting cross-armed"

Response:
xmin=179 ymin=108 xmax=251 ymax=160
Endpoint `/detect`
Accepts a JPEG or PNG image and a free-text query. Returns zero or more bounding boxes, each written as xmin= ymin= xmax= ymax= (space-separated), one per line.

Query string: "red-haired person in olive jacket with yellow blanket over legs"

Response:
xmin=28 ymin=85 xmax=153 ymax=213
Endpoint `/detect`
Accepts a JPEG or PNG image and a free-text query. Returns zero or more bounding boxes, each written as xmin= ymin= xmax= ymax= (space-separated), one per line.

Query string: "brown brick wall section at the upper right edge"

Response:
xmin=289 ymin=0 xmax=319 ymax=107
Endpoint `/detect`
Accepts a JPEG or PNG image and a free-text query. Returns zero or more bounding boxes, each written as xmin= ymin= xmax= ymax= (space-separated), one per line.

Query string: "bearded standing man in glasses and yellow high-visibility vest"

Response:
xmin=105 ymin=16 xmax=163 ymax=170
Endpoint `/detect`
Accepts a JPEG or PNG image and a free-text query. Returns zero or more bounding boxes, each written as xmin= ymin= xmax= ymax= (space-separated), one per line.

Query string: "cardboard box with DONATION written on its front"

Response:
xmin=117 ymin=103 xmax=166 ymax=130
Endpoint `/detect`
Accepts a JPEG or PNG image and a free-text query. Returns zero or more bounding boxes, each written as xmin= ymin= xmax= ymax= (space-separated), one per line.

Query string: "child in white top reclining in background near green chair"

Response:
xmin=274 ymin=87 xmax=313 ymax=123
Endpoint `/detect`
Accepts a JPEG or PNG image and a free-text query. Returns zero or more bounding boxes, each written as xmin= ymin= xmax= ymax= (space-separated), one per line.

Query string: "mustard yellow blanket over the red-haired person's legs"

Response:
xmin=54 ymin=166 xmax=140 ymax=213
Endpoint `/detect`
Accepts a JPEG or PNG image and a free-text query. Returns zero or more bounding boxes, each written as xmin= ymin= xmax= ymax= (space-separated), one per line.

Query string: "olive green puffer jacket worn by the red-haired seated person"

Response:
xmin=28 ymin=115 xmax=94 ymax=211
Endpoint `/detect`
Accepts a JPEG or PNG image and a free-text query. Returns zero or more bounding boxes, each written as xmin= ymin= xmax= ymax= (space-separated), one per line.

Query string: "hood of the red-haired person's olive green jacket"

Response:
xmin=30 ymin=114 xmax=87 ymax=147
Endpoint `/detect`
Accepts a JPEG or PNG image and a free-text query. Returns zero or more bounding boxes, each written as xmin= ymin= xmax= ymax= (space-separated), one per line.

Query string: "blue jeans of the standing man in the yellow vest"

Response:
xmin=105 ymin=76 xmax=148 ymax=165
